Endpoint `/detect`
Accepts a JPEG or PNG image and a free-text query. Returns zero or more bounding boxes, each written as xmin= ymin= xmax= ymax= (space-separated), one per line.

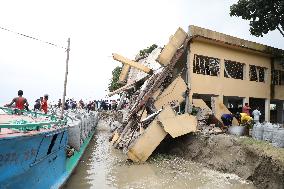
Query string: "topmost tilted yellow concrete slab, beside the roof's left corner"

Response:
xmin=157 ymin=28 xmax=187 ymax=66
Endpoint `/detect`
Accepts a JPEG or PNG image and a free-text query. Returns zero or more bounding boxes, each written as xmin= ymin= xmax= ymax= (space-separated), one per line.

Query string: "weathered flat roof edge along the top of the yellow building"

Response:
xmin=188 ymin=25 xmax=284 ymax=58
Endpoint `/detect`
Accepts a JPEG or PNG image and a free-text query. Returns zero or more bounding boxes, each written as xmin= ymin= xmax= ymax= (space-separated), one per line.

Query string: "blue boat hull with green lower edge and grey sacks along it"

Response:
xmin=0 ymin=113 xmax=98 ymax=189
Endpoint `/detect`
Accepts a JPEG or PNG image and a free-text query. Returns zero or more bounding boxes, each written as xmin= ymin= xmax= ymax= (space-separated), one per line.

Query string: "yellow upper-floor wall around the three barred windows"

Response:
xmin=189 ymin=40 xmax=272 ymax=99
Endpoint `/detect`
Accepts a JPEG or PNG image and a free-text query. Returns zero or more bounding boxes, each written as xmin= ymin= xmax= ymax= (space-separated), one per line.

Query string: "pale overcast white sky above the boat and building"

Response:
xmin=0 ymin=0 xmax=284 ymax=106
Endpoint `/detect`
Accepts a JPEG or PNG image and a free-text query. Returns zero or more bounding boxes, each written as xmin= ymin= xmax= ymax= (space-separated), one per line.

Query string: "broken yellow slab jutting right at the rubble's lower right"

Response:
xmin=158 ymin=113 xmax=197 ymax=138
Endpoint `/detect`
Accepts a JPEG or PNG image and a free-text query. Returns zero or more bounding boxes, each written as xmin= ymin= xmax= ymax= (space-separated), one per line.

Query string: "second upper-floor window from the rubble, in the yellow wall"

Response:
xmin=224 ymin=60 xmax=245 ymax=80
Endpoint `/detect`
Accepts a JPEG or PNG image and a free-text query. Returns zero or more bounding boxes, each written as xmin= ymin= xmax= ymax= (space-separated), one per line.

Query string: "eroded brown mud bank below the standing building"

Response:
xmin=156 ymin=134 xmax=284 ymax=189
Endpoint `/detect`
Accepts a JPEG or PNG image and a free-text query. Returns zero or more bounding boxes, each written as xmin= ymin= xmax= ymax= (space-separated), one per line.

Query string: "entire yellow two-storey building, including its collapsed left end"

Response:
xmin=109 ymin=26 xmax=284 ymax=162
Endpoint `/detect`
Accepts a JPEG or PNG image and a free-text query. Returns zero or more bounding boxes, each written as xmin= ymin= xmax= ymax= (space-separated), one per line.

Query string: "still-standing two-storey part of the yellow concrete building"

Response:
xmin=187 ymin=26 xmax=284 ymax=123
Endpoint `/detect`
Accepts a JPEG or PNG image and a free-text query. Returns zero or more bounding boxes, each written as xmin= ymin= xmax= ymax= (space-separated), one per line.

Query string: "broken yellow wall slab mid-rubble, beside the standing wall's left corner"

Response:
xmin=154 ymin=76 xmax=187 ymax=109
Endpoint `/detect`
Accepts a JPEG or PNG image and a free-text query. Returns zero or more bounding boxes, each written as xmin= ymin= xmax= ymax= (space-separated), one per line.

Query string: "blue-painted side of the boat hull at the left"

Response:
xmin=0 ymin=129 xmax=68 ymax=189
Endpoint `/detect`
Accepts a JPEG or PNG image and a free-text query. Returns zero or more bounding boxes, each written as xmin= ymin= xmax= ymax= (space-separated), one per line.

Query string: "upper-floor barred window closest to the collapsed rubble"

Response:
xmin=193 ymin=54 xmax=220 ymax=76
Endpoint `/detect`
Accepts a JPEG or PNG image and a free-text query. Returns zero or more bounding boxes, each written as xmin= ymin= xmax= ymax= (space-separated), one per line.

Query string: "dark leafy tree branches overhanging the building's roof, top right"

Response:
xmin=230 ymin=0 xmax=284 ymax=37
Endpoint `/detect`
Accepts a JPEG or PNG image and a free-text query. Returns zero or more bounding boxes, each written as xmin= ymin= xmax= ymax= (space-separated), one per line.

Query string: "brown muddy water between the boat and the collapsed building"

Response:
xmin=64 ymin=124 xmax=254 ymax=189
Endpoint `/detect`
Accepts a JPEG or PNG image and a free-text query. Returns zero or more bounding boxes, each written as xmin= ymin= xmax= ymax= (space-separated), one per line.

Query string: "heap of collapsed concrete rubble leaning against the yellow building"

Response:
xmin=109 ymin=28 xmax=200 ymax=162
